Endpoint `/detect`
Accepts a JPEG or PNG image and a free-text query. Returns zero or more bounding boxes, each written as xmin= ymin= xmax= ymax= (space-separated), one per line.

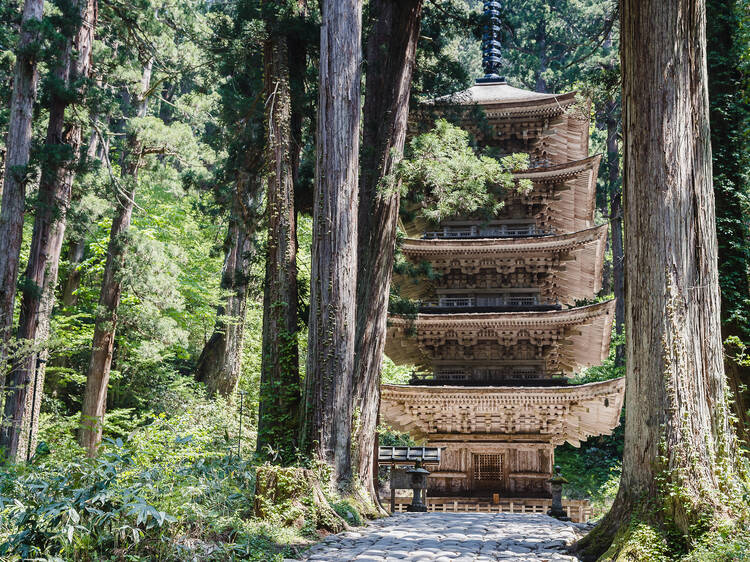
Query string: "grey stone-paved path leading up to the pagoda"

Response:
xmin=303 ymin=513 xmax=582 ymax=562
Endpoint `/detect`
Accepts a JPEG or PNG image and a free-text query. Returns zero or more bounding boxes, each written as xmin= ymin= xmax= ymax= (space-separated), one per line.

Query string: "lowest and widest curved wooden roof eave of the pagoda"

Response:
xmin=380 ymin=378 xmax=625 ymax=446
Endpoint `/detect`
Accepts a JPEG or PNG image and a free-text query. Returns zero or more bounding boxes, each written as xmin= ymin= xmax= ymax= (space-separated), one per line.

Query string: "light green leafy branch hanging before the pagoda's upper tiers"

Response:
xmin=396 ymin=119 xmax=531 ymax=223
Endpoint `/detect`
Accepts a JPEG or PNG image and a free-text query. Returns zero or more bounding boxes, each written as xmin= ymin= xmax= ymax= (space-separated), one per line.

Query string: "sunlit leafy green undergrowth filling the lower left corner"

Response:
xmin=0 ymin=392 xmax=361 ymax=561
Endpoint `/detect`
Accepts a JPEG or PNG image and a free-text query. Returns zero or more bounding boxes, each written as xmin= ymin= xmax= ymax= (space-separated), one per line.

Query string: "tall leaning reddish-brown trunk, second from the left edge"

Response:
xmin=0 ymin=0 xmax=97 ymax=458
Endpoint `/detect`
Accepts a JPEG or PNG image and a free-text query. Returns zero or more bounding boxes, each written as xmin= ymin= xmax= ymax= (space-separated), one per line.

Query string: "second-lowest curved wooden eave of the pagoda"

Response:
xmin=385 ymin=300 xmax=615 ymax=373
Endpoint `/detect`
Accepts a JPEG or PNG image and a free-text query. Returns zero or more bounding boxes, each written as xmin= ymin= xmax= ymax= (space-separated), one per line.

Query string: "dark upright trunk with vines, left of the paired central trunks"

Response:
xmin=257 ymin=31 xmax=300 ymax=461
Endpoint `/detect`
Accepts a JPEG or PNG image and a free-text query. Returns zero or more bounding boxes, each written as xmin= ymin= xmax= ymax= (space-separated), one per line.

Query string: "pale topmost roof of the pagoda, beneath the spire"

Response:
xmin=427 ymin=82 xmax=576 ymax=111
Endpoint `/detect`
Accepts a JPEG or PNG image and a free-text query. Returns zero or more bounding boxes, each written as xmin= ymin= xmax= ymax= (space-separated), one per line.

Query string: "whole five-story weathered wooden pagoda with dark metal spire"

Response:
xmin=381 ymin=1 xmax=624 ymax=508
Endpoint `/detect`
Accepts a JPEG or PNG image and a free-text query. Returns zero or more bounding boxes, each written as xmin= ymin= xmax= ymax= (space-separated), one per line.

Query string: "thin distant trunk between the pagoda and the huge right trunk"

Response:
xmin=605 ymin=99 xmax=625 ymax=365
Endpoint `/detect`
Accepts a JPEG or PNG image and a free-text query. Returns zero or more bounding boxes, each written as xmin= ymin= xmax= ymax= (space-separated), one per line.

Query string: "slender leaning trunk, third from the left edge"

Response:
xmin=78 ymin=59 xmax=153 ymax=456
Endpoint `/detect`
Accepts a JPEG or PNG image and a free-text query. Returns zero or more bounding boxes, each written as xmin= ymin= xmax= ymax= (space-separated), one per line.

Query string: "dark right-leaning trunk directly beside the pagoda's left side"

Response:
xmin=354 ymin=0 xmax=422 ymax=501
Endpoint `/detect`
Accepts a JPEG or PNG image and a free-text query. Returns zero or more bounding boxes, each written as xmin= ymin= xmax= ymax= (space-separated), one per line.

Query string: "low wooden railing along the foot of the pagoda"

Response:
xmin=384 ymin=496 xmax=592 ymax=523
